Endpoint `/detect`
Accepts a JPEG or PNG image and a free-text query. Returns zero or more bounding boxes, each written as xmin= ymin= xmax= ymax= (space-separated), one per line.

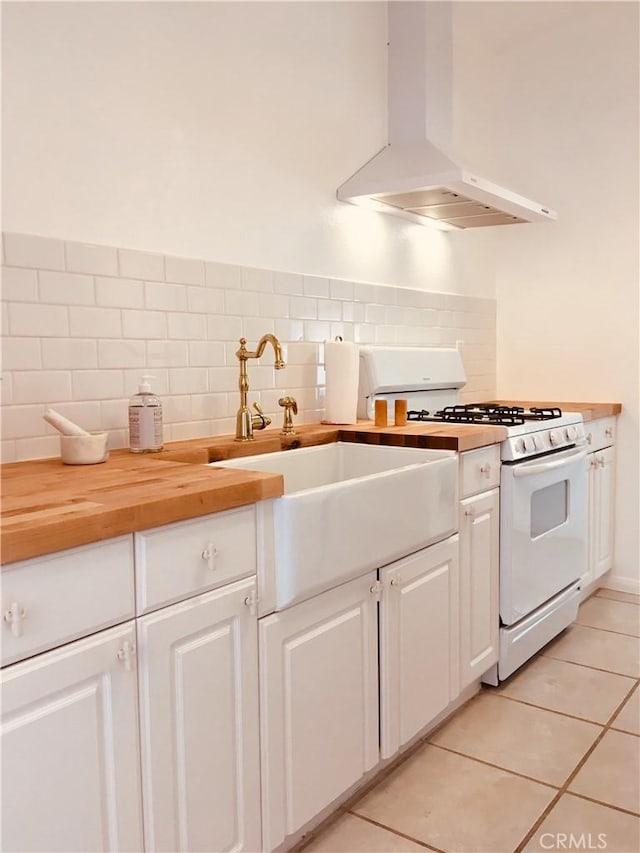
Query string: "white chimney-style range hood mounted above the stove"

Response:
xmin=337 ymin=0 xmax=557 ymax=231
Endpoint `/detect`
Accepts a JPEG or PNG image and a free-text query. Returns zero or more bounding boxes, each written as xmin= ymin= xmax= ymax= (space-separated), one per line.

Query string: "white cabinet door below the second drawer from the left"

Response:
xmin=138 ymin=578 xmax=260 ymax=853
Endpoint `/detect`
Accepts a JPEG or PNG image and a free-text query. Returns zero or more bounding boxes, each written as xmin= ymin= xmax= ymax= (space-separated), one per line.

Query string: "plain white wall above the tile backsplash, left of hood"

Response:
xmin=2 ymin=2 xmax=495 ymax=297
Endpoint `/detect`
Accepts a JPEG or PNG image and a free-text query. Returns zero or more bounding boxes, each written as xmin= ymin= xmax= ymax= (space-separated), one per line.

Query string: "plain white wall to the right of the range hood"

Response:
xmin=458 ymin=2 xmax=640 ymax=591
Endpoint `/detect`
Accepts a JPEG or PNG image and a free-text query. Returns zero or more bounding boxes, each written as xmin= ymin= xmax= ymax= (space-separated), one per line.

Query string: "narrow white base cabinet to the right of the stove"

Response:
xmin=582 ymin=417 xmax=615 ymax=594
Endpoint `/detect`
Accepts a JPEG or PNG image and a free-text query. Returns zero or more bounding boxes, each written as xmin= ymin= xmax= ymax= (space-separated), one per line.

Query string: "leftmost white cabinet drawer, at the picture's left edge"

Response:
xmin=2 ymin=536 xmax=135 ymax=666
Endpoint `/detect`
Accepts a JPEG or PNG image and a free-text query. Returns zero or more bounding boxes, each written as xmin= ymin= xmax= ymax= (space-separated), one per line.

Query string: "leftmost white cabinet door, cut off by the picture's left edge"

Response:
xmin=2 ymin=622 xmax=142 ymax=853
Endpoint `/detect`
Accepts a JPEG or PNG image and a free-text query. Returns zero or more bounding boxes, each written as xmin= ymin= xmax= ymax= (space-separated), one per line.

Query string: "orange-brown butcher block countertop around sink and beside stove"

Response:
xmin=0 ymin=400 xmax=622 ymax=564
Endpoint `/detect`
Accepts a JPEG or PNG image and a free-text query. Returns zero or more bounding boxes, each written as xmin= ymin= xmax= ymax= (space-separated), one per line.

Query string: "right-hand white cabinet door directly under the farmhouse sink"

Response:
xmin=380 ymin=536 xmax=459 ymax=758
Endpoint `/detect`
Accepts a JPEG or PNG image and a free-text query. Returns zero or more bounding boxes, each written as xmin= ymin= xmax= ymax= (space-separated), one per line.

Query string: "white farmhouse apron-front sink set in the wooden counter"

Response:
xmin=212 ymin=442 xmax=458 ymax=610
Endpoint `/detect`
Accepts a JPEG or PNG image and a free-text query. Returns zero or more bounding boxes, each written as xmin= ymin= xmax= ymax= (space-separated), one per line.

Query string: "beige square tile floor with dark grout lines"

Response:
xmin=297 ymin=589 xmax=640 ymax=853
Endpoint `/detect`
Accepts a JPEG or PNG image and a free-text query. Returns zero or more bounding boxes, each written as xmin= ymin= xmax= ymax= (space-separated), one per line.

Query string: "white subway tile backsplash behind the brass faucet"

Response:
xmin=2 ymin=230 xmax=496 ymax=459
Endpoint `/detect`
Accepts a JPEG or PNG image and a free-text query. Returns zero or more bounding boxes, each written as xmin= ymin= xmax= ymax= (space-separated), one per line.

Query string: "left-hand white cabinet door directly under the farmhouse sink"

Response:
xmin=259 ymin=572 xmax=378 ymax=851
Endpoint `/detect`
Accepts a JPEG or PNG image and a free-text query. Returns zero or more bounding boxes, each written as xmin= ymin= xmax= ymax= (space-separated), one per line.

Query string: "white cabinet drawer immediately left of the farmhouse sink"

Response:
xmin=134 ymin=506 xmax=257 ymax=614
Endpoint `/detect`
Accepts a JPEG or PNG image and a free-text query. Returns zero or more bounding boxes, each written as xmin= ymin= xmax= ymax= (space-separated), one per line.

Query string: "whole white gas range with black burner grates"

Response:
xmin=358 ymin=347 xmax=587 ymax=684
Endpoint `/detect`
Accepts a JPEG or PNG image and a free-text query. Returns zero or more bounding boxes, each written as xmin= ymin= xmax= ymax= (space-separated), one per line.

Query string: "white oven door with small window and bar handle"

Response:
xmin=500 ymin=448 xmax=587 ymax=625
